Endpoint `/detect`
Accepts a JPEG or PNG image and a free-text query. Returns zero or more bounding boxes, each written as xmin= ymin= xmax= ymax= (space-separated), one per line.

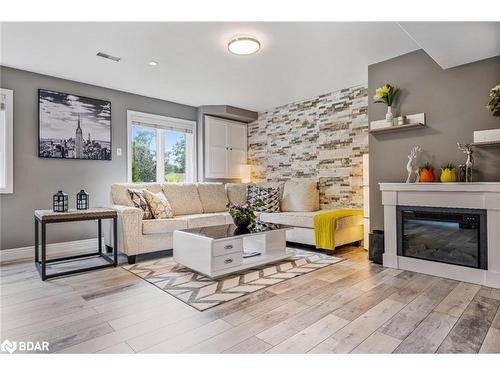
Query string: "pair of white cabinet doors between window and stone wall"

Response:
xmin=205 ymin=116 xmax=247 ymax=178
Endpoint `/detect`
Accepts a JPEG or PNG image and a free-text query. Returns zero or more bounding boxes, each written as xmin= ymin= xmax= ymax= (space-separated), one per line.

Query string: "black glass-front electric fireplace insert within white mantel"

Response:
xmin=397 ymin=206 xmax=487 ymax=269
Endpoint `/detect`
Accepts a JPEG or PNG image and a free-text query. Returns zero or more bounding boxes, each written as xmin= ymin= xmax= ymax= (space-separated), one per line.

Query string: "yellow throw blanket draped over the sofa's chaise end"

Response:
xmin=314 ymin=209 xmax=363 ymax=250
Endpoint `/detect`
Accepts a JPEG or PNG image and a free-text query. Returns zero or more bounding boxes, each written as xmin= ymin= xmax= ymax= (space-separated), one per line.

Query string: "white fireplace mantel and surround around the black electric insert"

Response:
xmin=379 ymin=182 xmax=500 ymax=288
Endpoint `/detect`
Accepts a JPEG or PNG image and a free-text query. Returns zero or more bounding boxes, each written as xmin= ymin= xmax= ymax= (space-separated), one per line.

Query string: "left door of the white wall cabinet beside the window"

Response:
xmin=205 ymin=116 xmax=229 ymax=178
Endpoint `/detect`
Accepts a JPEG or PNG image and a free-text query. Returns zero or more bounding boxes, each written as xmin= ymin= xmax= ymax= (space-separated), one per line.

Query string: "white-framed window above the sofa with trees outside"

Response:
xmin=127 ymin=111 xmax=196 ymax=182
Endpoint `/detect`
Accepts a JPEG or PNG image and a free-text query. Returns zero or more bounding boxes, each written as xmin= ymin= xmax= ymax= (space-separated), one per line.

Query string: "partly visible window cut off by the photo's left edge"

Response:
xmin=0 ymin=89 xmax=14 ymax=193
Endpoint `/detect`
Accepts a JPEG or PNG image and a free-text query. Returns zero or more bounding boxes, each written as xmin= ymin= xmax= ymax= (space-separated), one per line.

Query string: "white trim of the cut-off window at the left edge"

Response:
xmin=0 ymin=88 xmax=14 ymax=194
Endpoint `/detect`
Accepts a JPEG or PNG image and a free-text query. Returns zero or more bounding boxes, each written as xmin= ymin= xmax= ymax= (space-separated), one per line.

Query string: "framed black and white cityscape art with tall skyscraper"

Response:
xmin=38 ymin=89 xmax=112 ymax=160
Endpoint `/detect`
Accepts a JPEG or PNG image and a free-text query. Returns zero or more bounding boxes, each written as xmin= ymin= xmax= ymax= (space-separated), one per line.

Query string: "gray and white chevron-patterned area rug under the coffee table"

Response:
xmin=122 ymin=248 xmax=343 ymax=311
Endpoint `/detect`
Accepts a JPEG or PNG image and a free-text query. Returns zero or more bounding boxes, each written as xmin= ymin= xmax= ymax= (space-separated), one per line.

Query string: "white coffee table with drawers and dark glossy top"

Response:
xmin=173 ymin=223 xmax=294 ymax=278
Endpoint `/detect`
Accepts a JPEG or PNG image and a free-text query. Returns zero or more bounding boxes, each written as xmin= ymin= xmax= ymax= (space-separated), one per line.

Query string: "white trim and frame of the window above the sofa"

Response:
xmin=127 ymin=110 xmax=198 ymax=182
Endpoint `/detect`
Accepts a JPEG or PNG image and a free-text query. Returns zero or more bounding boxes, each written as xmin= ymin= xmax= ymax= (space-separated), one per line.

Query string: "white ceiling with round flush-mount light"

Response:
xmin=0 ymin=22 xmax=500 ymax=111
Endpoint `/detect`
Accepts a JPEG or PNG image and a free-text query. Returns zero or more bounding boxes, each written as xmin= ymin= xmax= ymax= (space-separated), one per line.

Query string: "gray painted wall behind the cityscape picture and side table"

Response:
xmin=0 ymin=67 xmax=197 ymax=249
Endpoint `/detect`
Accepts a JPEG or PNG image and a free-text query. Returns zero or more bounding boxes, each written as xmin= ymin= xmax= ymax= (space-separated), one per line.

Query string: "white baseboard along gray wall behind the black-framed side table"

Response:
xmin=0 ymin=238 xmax=104 ymax=264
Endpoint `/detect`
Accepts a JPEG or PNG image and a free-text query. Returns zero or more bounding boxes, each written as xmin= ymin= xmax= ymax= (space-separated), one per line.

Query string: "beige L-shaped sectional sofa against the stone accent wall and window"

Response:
xmin=105 ymin=182 xmax=363 ymax=263
